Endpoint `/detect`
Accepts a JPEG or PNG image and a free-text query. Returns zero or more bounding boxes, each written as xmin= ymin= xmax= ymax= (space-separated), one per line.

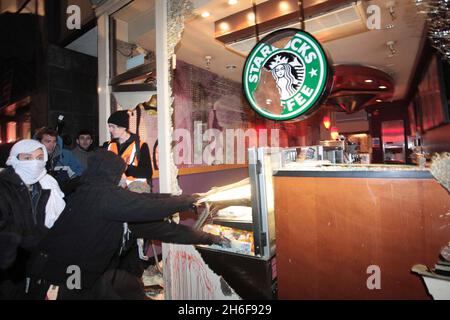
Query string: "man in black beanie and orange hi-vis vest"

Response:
xmin=103 ymin=110 xmax=153 ymax=189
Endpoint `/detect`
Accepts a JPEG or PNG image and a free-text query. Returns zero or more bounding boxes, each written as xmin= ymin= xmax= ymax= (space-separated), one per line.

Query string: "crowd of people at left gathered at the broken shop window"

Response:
xmin=0 ymin=111 xmax=230 ymax=300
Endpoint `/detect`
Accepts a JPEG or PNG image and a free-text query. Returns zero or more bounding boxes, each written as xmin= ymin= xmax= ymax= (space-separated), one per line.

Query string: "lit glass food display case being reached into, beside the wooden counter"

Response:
xmin=195 ymin=147 xmax=281 ymax=299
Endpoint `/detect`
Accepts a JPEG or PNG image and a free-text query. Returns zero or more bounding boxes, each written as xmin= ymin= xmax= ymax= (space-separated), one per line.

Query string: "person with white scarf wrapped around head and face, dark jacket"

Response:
xmin=0 ymin=140 xmax=65 ymax=299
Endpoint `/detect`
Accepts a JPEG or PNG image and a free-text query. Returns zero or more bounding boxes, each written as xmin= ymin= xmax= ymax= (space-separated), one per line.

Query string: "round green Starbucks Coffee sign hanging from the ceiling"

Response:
xmin=242 ymin=29 xmax=329 ymax=120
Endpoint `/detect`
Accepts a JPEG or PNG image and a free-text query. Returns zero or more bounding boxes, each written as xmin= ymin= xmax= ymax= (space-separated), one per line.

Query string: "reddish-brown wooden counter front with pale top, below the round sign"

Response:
xmin=274 ymin=162 xmax=450 ymax=299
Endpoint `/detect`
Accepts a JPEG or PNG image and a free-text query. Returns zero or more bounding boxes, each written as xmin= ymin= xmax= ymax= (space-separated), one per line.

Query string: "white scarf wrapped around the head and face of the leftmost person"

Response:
xmin=6 ymin=139 xmax=66 ymax=228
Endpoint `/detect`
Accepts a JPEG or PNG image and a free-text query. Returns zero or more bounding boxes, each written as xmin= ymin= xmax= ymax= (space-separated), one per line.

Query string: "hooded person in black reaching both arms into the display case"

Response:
xmin=31 ymin=149 xmax=227 ymax=299
